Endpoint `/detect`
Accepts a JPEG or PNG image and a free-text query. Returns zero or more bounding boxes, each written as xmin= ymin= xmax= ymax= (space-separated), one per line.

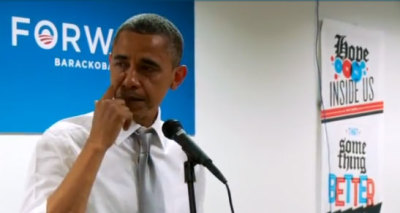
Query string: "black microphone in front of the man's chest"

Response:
xmin=162 ymin=120 xmax=228 ymax=184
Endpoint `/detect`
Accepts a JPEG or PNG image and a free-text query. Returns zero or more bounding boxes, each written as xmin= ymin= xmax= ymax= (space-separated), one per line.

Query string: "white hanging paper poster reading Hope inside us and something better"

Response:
xmin=321 ymin=20 xmax=384 ymax=213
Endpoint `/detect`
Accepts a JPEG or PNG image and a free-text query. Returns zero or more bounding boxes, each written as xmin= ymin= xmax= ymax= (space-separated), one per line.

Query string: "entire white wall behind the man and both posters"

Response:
xmin=0 ymin=1 xmax=400 ymax=213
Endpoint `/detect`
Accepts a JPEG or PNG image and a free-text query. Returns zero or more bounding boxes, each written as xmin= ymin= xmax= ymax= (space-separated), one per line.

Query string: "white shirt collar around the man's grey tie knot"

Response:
xmin=115 ymin=109 xmax=165 ymax=148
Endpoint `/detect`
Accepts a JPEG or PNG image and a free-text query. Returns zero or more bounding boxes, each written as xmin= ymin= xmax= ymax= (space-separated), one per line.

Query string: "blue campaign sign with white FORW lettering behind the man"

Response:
xmin=0 ymin=1 xmax=195 ymax=134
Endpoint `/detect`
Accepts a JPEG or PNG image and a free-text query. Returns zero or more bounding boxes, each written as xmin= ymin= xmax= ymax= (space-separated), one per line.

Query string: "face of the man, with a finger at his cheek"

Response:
xmin=110 ymin=31 xmax=186 ymax=121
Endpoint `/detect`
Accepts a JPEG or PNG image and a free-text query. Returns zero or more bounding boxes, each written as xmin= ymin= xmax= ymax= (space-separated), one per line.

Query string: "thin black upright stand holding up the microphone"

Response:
xmin=184 ymin=156 xmax=196 ymax=213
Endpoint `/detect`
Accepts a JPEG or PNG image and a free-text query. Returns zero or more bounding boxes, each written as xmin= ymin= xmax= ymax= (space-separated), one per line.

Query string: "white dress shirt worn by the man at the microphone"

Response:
xmin=21 ymin=112 xmax=205 ymax=213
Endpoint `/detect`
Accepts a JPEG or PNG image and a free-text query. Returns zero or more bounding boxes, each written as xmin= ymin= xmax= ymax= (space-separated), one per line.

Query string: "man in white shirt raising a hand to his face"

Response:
xmin=22 ymin=14 xmax=204 ymax=213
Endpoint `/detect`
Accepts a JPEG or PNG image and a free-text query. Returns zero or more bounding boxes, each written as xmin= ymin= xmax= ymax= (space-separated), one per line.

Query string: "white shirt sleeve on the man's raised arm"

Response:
xmin=21 ymin=131 xmax=69 ymax=213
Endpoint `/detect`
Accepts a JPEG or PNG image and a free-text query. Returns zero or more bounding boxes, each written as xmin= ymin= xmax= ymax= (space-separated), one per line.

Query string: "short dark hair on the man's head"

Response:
xmin=113 ymin=13 xmax=183 ymax=67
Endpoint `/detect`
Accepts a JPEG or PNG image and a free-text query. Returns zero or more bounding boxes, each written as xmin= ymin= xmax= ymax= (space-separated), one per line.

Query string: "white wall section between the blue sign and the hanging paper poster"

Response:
xmin=196 ymin=2 xmax=318 ymax=213
